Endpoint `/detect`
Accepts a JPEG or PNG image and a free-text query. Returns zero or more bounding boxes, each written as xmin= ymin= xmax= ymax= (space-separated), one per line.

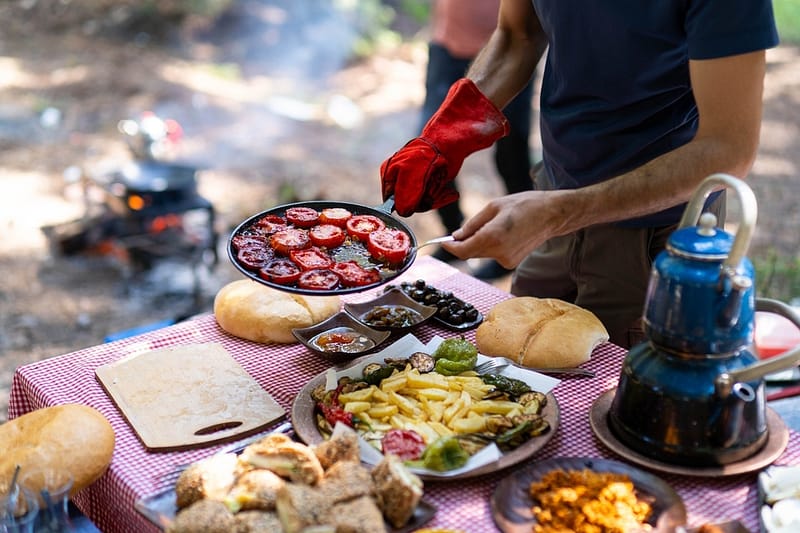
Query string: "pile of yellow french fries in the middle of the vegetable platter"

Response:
xmin=339 ymin=365 xmax=521 ymax=444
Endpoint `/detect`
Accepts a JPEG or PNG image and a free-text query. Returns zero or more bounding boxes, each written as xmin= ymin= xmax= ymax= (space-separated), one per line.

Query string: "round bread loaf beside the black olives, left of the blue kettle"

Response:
xmin=475 ymin=296 xmax=608 ymax=368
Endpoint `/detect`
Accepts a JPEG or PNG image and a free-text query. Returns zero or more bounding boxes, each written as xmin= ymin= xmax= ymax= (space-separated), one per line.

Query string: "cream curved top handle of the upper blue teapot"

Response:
xmin=678 ymin=173 xmax=758 ymax=275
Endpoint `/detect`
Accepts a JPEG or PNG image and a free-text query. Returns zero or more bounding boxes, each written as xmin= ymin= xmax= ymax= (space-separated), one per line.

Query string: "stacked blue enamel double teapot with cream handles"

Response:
xmin=608 ymin=174 xmax=800 ymax=466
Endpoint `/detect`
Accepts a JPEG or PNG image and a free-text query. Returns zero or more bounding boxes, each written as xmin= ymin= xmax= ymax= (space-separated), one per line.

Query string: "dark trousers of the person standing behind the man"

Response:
xmin=420 ymin=43 xmax=533 ymax=233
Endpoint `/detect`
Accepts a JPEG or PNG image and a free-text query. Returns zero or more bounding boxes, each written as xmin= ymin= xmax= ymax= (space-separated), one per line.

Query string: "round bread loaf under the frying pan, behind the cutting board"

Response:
xmin=214 ymin=279 xmax=341 ymax=344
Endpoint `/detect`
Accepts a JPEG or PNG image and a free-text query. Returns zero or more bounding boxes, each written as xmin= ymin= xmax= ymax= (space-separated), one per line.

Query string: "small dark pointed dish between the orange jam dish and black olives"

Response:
xmin=344 ymin=288 xmax=437 ymax=332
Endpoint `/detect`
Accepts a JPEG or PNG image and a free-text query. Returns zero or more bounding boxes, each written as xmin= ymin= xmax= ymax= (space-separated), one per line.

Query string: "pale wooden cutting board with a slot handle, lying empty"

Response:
xmin=95 ymin=343 xmax=285 ymax=451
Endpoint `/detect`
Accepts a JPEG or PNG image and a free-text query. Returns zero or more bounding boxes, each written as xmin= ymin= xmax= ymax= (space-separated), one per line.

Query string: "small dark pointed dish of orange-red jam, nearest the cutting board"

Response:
xmin=292 ymin=311 xmax=391 ymax=362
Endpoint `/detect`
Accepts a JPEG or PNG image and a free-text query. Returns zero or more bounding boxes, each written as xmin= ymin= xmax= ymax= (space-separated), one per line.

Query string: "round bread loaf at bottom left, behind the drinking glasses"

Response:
xmin=0 ymin=404 xmax=114 ymax=496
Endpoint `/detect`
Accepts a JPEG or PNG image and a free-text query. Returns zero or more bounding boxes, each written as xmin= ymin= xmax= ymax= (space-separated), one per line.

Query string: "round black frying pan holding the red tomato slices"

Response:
xmin=228 ymin=196 xmax=417 ymax=296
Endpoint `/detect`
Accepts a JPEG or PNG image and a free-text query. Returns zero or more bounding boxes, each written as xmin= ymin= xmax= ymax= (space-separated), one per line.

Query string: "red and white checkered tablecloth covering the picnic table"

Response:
xmin=9 ymin=257 xmax=800 ymax=533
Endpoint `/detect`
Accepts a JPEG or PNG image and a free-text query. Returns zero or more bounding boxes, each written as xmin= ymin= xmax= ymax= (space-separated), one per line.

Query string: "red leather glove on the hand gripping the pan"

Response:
xmin=381 ymin=78 xmax=508 ymax=217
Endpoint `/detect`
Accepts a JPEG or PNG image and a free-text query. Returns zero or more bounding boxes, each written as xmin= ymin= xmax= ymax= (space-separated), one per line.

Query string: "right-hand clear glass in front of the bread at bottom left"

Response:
xmin=20 ymin=470 xmax=73 ymax=533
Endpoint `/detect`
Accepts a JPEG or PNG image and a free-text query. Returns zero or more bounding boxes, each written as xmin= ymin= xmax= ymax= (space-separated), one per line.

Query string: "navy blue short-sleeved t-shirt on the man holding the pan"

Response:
xmin=532 ymin=0 xmax=778 ymax=226
